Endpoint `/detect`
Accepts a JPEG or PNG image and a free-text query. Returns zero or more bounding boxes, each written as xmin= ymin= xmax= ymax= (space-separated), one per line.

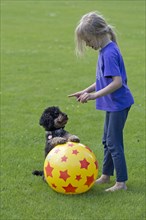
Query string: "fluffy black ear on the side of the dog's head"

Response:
xmin=39 ymin=113 xmax=54 ymax=131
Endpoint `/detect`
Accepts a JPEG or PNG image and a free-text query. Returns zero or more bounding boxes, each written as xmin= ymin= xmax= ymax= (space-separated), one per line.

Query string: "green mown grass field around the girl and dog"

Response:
xmin=1 ymin=0 xmax=146 ymax=220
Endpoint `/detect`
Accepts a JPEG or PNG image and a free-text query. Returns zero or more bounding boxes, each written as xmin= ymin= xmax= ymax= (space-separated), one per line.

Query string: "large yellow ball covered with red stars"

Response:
xmin=44 ymin=142 xmax=98 ymax=194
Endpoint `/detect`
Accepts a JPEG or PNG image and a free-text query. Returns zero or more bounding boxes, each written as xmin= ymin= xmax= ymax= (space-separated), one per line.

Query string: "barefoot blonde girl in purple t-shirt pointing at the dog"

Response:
xmin=69 ymin=12 xmax=134 ymax=191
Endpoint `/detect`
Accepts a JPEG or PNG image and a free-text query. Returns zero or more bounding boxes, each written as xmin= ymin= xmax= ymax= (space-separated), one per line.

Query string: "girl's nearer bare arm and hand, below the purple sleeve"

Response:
xmin=78 ymin=76 xmax=122 ymax=103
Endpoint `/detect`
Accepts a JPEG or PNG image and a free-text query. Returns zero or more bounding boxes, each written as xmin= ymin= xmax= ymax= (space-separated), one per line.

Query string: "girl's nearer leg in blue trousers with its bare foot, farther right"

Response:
xmin=106 ymin=108 xmax=129 ymax=191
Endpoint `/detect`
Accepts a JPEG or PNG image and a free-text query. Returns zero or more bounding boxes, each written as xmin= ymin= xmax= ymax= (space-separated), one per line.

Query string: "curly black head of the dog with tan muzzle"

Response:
xmin=39 ymin=106 xmax=68 ymax=131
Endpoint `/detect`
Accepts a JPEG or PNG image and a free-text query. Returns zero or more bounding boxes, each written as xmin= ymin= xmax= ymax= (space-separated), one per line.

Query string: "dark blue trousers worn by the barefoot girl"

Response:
xmin=102 ymin=108 xmax=130 ymax=182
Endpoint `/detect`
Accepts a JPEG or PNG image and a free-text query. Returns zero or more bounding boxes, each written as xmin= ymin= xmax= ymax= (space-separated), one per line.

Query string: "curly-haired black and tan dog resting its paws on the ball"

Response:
xmin=33 ymin=106 xmax=80 ymax=176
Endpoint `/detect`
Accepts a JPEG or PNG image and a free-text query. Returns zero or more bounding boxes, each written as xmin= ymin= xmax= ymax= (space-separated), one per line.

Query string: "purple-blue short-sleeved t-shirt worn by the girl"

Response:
xmin=96 ymin=42 xmax=134 ymax=112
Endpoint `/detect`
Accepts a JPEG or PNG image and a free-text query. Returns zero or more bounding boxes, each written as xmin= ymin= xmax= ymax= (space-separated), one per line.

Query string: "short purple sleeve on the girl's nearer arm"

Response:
xmin=103 ymin=52 xmax=121 ymax=77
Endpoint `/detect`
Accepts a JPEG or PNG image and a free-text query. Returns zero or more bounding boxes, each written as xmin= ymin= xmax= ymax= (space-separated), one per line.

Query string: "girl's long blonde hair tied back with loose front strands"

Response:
xmin=75 ymin=12 xmax=117 ymax=55
